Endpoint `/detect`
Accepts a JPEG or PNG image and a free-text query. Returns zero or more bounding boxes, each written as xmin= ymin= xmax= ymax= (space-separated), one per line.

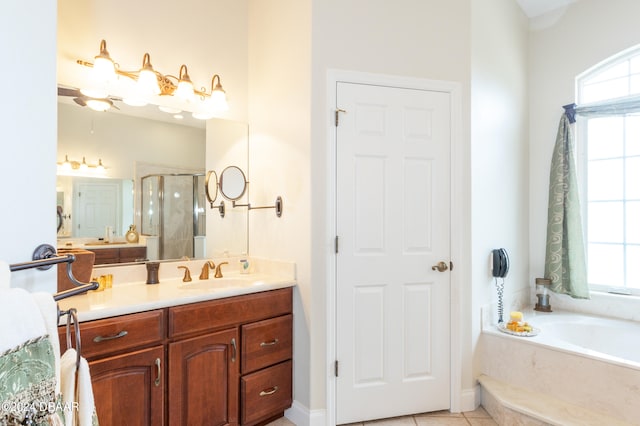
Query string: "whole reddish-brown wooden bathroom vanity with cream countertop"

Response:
xmin=60 ymin=262 xmax=295 ymax=425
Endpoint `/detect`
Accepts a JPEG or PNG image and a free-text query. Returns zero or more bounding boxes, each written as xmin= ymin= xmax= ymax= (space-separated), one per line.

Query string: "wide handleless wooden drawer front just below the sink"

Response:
xmin=169 ymin=288 xmax=293 ymax=339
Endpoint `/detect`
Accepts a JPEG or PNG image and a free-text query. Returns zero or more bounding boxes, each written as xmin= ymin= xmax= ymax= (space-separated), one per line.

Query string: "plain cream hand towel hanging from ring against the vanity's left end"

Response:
xmin=60 ymin=348 xmax=95 ymax=426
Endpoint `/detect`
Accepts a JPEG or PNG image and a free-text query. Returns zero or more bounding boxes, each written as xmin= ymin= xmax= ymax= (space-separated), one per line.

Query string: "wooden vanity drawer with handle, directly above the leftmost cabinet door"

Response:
xmin=59 ymin=310 xmax=164 ymax=360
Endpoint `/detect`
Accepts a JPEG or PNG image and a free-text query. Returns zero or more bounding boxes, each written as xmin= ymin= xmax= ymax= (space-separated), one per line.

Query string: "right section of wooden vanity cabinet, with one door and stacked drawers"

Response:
xmin=168 ymin=288 xmax=293 ymax=425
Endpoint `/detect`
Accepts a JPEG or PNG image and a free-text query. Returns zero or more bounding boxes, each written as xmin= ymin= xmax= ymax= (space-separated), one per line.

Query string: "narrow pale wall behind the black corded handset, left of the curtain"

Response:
xmin=470 ymin=0 xmax=530 ymax=386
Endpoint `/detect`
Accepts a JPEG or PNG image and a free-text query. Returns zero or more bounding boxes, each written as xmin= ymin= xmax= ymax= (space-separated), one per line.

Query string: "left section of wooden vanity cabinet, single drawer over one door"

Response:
xmin=59 ymin=309 xmax=166 ymax=425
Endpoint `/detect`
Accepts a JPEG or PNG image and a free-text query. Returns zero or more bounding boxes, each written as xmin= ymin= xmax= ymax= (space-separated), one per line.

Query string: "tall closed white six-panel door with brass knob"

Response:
xmin=336 ymin=83 xmax=451 ymax=424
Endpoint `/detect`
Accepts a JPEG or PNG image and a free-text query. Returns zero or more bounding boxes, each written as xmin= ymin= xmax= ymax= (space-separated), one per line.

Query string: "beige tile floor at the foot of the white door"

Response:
xmin=267 ymin=407 xmax=498 ymax=426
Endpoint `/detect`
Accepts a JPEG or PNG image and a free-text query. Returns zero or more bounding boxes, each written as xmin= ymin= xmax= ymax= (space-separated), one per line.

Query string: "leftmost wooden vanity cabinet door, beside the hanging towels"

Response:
xmin=89 ymin=346 xmax=165 ymax=426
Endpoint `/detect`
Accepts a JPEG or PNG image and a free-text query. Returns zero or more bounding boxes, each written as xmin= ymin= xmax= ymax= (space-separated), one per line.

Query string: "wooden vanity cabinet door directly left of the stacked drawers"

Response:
xmin=169 ymin=328 xmax=240 ymax=426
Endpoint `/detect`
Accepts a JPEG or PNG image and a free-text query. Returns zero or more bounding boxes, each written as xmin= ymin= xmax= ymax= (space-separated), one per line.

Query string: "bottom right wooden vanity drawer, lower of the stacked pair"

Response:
xmin=240 ymin=361 xmax=292 ymax=425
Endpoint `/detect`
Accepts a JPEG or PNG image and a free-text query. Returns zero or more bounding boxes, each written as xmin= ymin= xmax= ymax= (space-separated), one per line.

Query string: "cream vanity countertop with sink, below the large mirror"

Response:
xmin=58 ymin=258 xmax=296 ymax=321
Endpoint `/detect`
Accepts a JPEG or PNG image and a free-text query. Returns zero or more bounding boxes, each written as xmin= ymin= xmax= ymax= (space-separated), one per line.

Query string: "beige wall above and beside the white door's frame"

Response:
xmin=308 ymin=0 xmax=472 ymax=409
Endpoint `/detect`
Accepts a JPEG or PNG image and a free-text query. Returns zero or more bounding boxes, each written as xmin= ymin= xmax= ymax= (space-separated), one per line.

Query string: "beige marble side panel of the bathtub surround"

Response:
xmin=478 ymin=313 xmax=640 ymax=424
